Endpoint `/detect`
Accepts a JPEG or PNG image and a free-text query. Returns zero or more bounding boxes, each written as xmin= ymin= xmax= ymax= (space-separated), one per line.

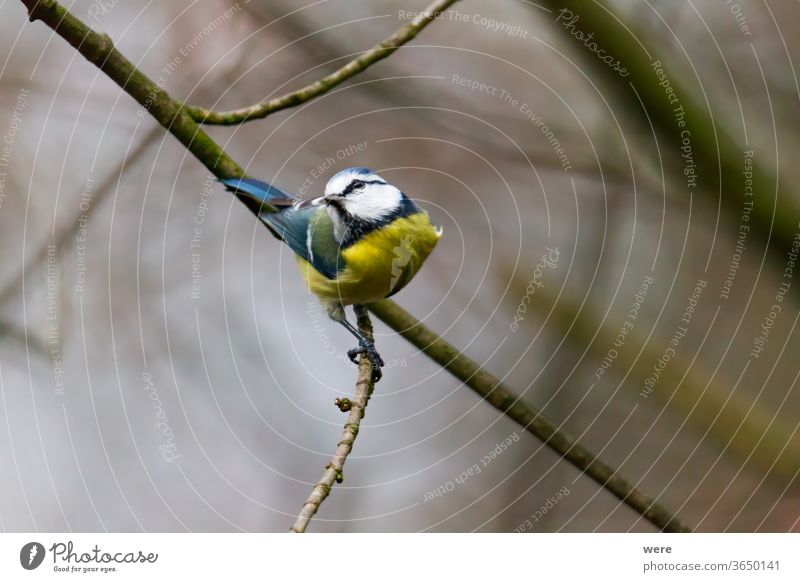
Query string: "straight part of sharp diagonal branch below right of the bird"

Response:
xmin=369 ymin=300 xmax=690 ymax=532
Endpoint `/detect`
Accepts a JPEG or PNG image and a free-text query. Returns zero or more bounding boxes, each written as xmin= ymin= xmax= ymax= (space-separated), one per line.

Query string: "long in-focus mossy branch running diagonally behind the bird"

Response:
xmin=21 ymin=0 xmax=687 ymax=531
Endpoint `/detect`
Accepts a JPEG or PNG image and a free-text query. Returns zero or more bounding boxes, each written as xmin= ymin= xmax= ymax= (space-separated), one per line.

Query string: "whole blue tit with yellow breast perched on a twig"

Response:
xmin=220 ymin=167 xmax=442 ymax=382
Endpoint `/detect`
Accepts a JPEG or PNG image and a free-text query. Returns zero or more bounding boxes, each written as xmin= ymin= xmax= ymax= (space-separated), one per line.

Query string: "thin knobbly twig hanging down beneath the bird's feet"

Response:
xmin=291 ymin=305 xmax=374 ymax=533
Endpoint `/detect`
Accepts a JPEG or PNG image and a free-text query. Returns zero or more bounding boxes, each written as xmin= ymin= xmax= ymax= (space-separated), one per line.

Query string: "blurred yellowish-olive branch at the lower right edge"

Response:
xmin=506 ymin=277 xmax=800 ymax=479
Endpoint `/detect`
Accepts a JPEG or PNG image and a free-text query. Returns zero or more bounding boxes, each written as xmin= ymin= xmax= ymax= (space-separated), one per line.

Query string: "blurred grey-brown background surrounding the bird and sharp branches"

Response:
xmin=0 ymin=0 xmax=800 ymax=532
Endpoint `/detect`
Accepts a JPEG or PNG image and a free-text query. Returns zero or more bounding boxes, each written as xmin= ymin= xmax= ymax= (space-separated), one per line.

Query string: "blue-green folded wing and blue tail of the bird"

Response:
xmin=221 ymin=178 xmax=345 ymax=279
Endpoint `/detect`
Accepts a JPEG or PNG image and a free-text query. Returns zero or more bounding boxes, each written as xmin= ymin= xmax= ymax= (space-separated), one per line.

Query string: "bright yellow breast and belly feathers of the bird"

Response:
xmin=297 ymin=212 xmax=442 ymax=305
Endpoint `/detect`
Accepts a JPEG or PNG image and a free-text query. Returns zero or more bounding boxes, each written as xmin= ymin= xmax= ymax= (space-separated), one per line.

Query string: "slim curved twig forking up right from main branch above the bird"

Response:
xmin=181 ymin=0 xmax=458 ymax=125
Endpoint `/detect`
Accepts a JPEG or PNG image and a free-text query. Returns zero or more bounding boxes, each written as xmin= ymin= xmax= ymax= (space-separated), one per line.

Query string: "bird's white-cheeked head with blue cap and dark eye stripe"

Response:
xmin=322 ymin=168 xmax=419 ymax=244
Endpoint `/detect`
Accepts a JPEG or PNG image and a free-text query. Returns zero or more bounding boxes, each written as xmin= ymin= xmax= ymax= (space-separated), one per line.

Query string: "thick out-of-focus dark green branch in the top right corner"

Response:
xmin=543 ymin=0 xmax=800 ymax=288
